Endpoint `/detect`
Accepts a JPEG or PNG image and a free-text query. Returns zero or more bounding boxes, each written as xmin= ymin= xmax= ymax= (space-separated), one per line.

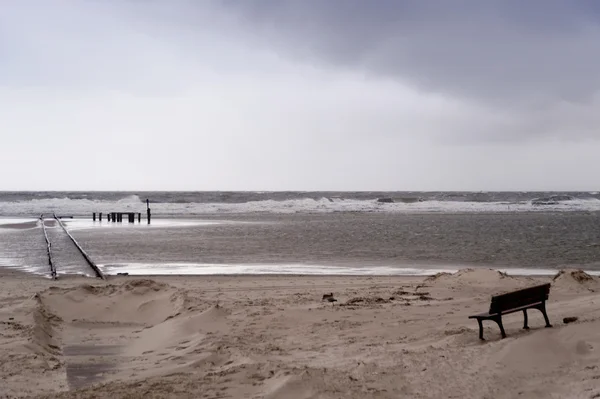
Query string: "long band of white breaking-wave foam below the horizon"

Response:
xmin=0 ymin=195 xmax=600 ymax=216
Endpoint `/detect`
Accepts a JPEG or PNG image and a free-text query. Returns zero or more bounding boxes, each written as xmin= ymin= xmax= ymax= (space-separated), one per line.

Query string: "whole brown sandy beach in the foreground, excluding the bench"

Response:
xmin=0 ymin=269 xmax=600 ymax=399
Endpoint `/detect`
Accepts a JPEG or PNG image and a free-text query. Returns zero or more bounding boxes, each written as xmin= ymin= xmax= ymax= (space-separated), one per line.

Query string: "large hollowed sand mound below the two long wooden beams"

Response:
xmin=30 ymin=279 xmax=214 ymax=389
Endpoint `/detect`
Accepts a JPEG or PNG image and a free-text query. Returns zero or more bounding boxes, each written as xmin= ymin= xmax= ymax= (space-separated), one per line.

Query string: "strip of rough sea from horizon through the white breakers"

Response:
xmin=0 ymin=191 xmax=600 ymax=217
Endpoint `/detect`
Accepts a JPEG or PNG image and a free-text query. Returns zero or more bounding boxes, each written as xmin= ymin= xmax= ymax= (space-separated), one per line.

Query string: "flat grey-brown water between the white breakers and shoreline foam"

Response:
xmin=67 ymin=212 xmax=600 ymax=270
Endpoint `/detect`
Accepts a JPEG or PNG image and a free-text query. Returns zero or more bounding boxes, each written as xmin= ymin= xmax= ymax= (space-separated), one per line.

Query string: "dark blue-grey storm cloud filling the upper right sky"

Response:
xmin=225 ymin=0 xmax=600 ymax=108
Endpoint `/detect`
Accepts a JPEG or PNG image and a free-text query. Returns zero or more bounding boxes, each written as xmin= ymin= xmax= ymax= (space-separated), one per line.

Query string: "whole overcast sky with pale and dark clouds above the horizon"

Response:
xmin=0 ymin=0 xmax=600 ymax=191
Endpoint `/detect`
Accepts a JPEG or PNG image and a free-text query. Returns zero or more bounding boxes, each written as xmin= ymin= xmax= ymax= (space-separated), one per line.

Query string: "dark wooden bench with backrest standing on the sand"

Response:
xmin=469 ymin=284 xmax=552 ymax=339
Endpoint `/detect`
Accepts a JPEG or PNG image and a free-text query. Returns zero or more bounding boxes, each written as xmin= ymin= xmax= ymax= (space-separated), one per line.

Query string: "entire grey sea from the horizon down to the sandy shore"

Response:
xmin=0 ymin=191 xmax=600 ymax=276
